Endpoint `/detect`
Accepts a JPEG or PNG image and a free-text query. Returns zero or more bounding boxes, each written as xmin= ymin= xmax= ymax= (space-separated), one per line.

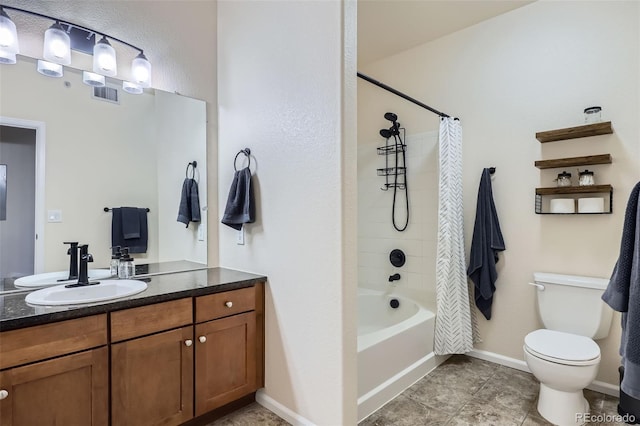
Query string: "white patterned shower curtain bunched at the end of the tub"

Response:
xmin=434 ymin=117 xmax=474 ymax=355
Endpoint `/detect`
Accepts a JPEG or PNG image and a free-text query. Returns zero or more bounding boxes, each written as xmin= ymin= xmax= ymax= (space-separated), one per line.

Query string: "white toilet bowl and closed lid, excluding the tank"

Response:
xmin=523 ymin=329 xmax=600 ymax=426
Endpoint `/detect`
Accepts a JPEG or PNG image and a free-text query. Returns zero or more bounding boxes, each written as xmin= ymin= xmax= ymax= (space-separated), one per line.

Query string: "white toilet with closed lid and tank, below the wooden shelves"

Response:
xmin=524 ymin=272 xmax=613 ymax=426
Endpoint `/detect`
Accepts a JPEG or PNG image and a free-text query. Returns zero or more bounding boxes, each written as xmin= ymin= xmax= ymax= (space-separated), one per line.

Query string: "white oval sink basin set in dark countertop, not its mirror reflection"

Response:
xmin=25 ymin=280 xmax=147 ymax=306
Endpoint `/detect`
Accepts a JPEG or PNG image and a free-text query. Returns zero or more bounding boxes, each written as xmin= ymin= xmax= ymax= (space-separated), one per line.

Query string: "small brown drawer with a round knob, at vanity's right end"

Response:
xmin=196 ymin=287 xmax=256 ymax=322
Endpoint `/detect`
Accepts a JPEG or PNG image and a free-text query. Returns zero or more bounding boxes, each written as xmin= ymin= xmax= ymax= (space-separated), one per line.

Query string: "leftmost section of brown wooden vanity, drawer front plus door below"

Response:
xmin=0 ymin=314 xmax=109 ymax=426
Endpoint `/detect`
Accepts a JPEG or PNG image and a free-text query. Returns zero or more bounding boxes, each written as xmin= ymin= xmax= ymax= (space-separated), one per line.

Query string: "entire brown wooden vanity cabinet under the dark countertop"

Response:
xmin=0 ymin=283 xmax=264 ymax=426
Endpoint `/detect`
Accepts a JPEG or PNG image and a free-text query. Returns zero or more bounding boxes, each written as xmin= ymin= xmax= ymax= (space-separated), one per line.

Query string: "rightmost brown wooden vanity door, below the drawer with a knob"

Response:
xmin=195 ymin=311 xmax=257 ymax=415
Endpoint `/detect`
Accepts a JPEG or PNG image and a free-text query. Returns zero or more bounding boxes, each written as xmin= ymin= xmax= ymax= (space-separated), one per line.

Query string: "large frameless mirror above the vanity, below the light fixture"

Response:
xmin=0 ymin=56 xmax=207 ymax=290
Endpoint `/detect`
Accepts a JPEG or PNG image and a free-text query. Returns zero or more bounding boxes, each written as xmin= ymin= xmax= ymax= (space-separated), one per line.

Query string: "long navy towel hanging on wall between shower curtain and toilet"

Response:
xmin=467 ymin=169 xmax=505 ymax=320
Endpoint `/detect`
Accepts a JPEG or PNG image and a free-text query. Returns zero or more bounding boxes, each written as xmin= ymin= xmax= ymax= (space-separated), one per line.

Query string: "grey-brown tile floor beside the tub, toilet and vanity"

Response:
xmin=209 ymin=355 xmax=624 ymax=426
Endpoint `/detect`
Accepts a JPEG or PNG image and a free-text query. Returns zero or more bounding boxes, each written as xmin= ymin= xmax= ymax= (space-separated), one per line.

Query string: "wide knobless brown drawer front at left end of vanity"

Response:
xmin=0 ymin=314 xmax=107 ymax=369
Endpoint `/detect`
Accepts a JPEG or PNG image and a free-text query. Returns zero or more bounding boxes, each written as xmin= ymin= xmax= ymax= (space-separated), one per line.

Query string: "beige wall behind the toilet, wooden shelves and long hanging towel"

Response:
xmin=358 ymin=2 xmax=640 ymax=384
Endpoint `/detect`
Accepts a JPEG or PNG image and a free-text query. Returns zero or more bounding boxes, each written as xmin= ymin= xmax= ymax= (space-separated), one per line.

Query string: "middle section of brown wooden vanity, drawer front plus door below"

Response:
xmin=111 ymin=298 xmax=193 ymax=426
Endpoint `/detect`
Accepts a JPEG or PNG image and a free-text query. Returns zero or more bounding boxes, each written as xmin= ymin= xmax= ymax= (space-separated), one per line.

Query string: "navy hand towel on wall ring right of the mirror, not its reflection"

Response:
xmin=222 ymin=167 xmax=256 ymax=230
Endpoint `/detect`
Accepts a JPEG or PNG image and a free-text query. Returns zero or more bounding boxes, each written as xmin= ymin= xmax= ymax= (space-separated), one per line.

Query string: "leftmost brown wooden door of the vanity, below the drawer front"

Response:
xmin=0 ymin=347 xmax=109 ymax=426
